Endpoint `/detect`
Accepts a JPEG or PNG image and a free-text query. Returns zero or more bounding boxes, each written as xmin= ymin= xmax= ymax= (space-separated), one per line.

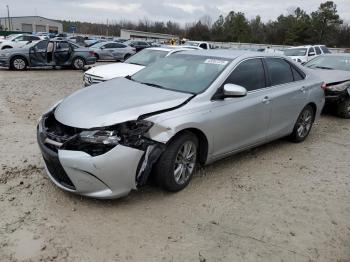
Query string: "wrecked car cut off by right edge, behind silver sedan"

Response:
xmin=304 ymin=53 xmax=350 ymax=118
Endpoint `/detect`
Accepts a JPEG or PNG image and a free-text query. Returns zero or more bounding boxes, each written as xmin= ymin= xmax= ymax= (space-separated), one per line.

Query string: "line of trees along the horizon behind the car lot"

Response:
xmin=63 ymin=1 xmax=350 ymax=47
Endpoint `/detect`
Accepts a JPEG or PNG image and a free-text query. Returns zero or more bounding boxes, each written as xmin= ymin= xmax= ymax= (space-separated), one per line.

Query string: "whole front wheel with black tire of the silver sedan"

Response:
xmin=154 ymin=132 xmax=198 ymax=192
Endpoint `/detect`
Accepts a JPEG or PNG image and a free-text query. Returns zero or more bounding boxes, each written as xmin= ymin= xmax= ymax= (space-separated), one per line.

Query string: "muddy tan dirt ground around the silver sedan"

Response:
xmin=0 ymin=65 xmax=350 ymax=262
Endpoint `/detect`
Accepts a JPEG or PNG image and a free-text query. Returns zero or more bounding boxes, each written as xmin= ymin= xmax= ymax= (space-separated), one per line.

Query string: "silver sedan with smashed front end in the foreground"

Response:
xmin=37 ymin=50 xmax=324 ymax=198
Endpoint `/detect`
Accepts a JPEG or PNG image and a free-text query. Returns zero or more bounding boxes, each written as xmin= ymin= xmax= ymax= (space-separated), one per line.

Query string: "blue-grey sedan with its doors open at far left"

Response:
xmin=0 ymin=40 xmax=96 ymax=70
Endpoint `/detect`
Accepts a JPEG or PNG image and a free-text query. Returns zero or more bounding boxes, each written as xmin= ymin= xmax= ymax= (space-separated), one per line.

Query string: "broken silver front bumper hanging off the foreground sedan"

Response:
xmin=37 ymin=130 xmax=144 ymax=199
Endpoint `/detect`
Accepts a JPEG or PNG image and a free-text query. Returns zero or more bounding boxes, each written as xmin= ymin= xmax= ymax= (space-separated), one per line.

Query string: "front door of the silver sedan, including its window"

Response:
xmin=211 ymin=58 xmax=271 ymax=157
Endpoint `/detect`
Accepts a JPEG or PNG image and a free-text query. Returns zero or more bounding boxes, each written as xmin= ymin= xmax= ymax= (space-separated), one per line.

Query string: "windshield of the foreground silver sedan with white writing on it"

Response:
xmin=131 ymin=54 xmax=231 ymax=94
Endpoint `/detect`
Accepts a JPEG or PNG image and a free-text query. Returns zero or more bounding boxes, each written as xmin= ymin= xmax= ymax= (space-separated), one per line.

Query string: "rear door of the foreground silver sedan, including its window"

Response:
xmin=264 ymin=57 xmax=308 ymax=139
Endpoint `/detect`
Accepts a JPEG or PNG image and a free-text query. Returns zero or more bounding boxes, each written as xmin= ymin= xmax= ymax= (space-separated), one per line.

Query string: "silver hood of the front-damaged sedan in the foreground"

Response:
xmin=55 ymin=78 xmax=192 ymax=129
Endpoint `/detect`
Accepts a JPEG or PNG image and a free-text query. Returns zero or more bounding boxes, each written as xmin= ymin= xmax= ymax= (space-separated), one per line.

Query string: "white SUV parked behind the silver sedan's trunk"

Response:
xmin=284 ymin=45 xmax=330 ymax=64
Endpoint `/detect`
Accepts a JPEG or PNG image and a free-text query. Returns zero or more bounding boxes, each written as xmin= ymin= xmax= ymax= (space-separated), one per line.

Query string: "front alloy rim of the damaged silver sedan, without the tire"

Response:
xmin=174 ymin=141 xmax=197 ymax=185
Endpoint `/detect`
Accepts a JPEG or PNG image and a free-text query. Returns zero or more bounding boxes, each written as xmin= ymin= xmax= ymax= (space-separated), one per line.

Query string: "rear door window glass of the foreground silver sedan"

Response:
xmin=265 ymin=58 xmax=294 ymax=86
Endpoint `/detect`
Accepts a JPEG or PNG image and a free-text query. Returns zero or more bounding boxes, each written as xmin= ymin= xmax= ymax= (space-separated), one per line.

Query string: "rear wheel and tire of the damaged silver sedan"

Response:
xmin=289 ymin=105 xmax=316 ymax=143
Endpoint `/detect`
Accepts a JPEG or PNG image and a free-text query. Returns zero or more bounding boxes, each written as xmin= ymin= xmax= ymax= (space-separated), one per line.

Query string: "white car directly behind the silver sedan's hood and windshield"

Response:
xmin=84 ymin=46 xmax=194 ymax=86
